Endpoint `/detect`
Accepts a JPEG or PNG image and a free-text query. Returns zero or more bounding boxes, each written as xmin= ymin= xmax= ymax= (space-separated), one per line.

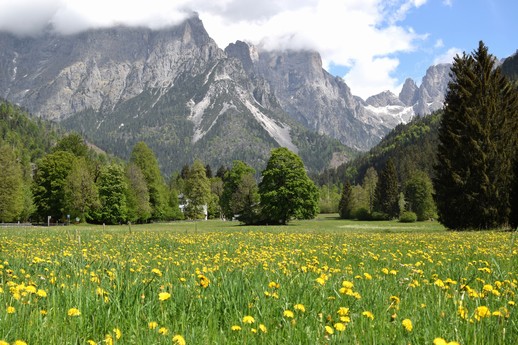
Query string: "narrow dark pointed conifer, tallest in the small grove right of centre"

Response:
xmin=374 ymin=159 xmax=399 ymax=218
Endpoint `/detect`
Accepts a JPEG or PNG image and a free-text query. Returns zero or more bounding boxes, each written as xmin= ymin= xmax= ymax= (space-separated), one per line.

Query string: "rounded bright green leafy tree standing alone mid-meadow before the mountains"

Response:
xmin=259 ymin=147 xmax=318 ymax=224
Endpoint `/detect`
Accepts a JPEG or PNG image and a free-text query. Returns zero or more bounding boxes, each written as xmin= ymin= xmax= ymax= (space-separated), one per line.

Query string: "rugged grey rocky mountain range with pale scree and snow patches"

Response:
xmin=0 ymin=15 xmax=456 ymax=176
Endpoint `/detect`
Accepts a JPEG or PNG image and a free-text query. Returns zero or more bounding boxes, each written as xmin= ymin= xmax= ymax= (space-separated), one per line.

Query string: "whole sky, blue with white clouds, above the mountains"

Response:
xmin=0 ymin=0 xmax=518 ymax=99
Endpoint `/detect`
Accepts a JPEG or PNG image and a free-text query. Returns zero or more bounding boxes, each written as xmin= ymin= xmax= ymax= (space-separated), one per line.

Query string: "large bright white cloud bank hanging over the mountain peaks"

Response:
xmin=0 ymin=0 xmax=426 ymax=97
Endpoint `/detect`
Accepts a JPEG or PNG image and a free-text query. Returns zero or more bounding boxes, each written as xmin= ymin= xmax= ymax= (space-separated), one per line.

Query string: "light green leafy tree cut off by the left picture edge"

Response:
xmin=0 ymin=141 xmax=24 ymax=223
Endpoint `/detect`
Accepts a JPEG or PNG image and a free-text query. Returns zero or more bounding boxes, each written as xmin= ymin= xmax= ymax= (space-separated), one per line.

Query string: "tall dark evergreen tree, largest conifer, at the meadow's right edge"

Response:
xmin=434 ymin=42 xmax=518 ymax=230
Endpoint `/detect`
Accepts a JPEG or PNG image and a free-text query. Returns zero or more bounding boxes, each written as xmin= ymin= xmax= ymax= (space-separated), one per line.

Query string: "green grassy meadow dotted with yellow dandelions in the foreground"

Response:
xmin=0 ymin=220 xmax=518 ymax=345
